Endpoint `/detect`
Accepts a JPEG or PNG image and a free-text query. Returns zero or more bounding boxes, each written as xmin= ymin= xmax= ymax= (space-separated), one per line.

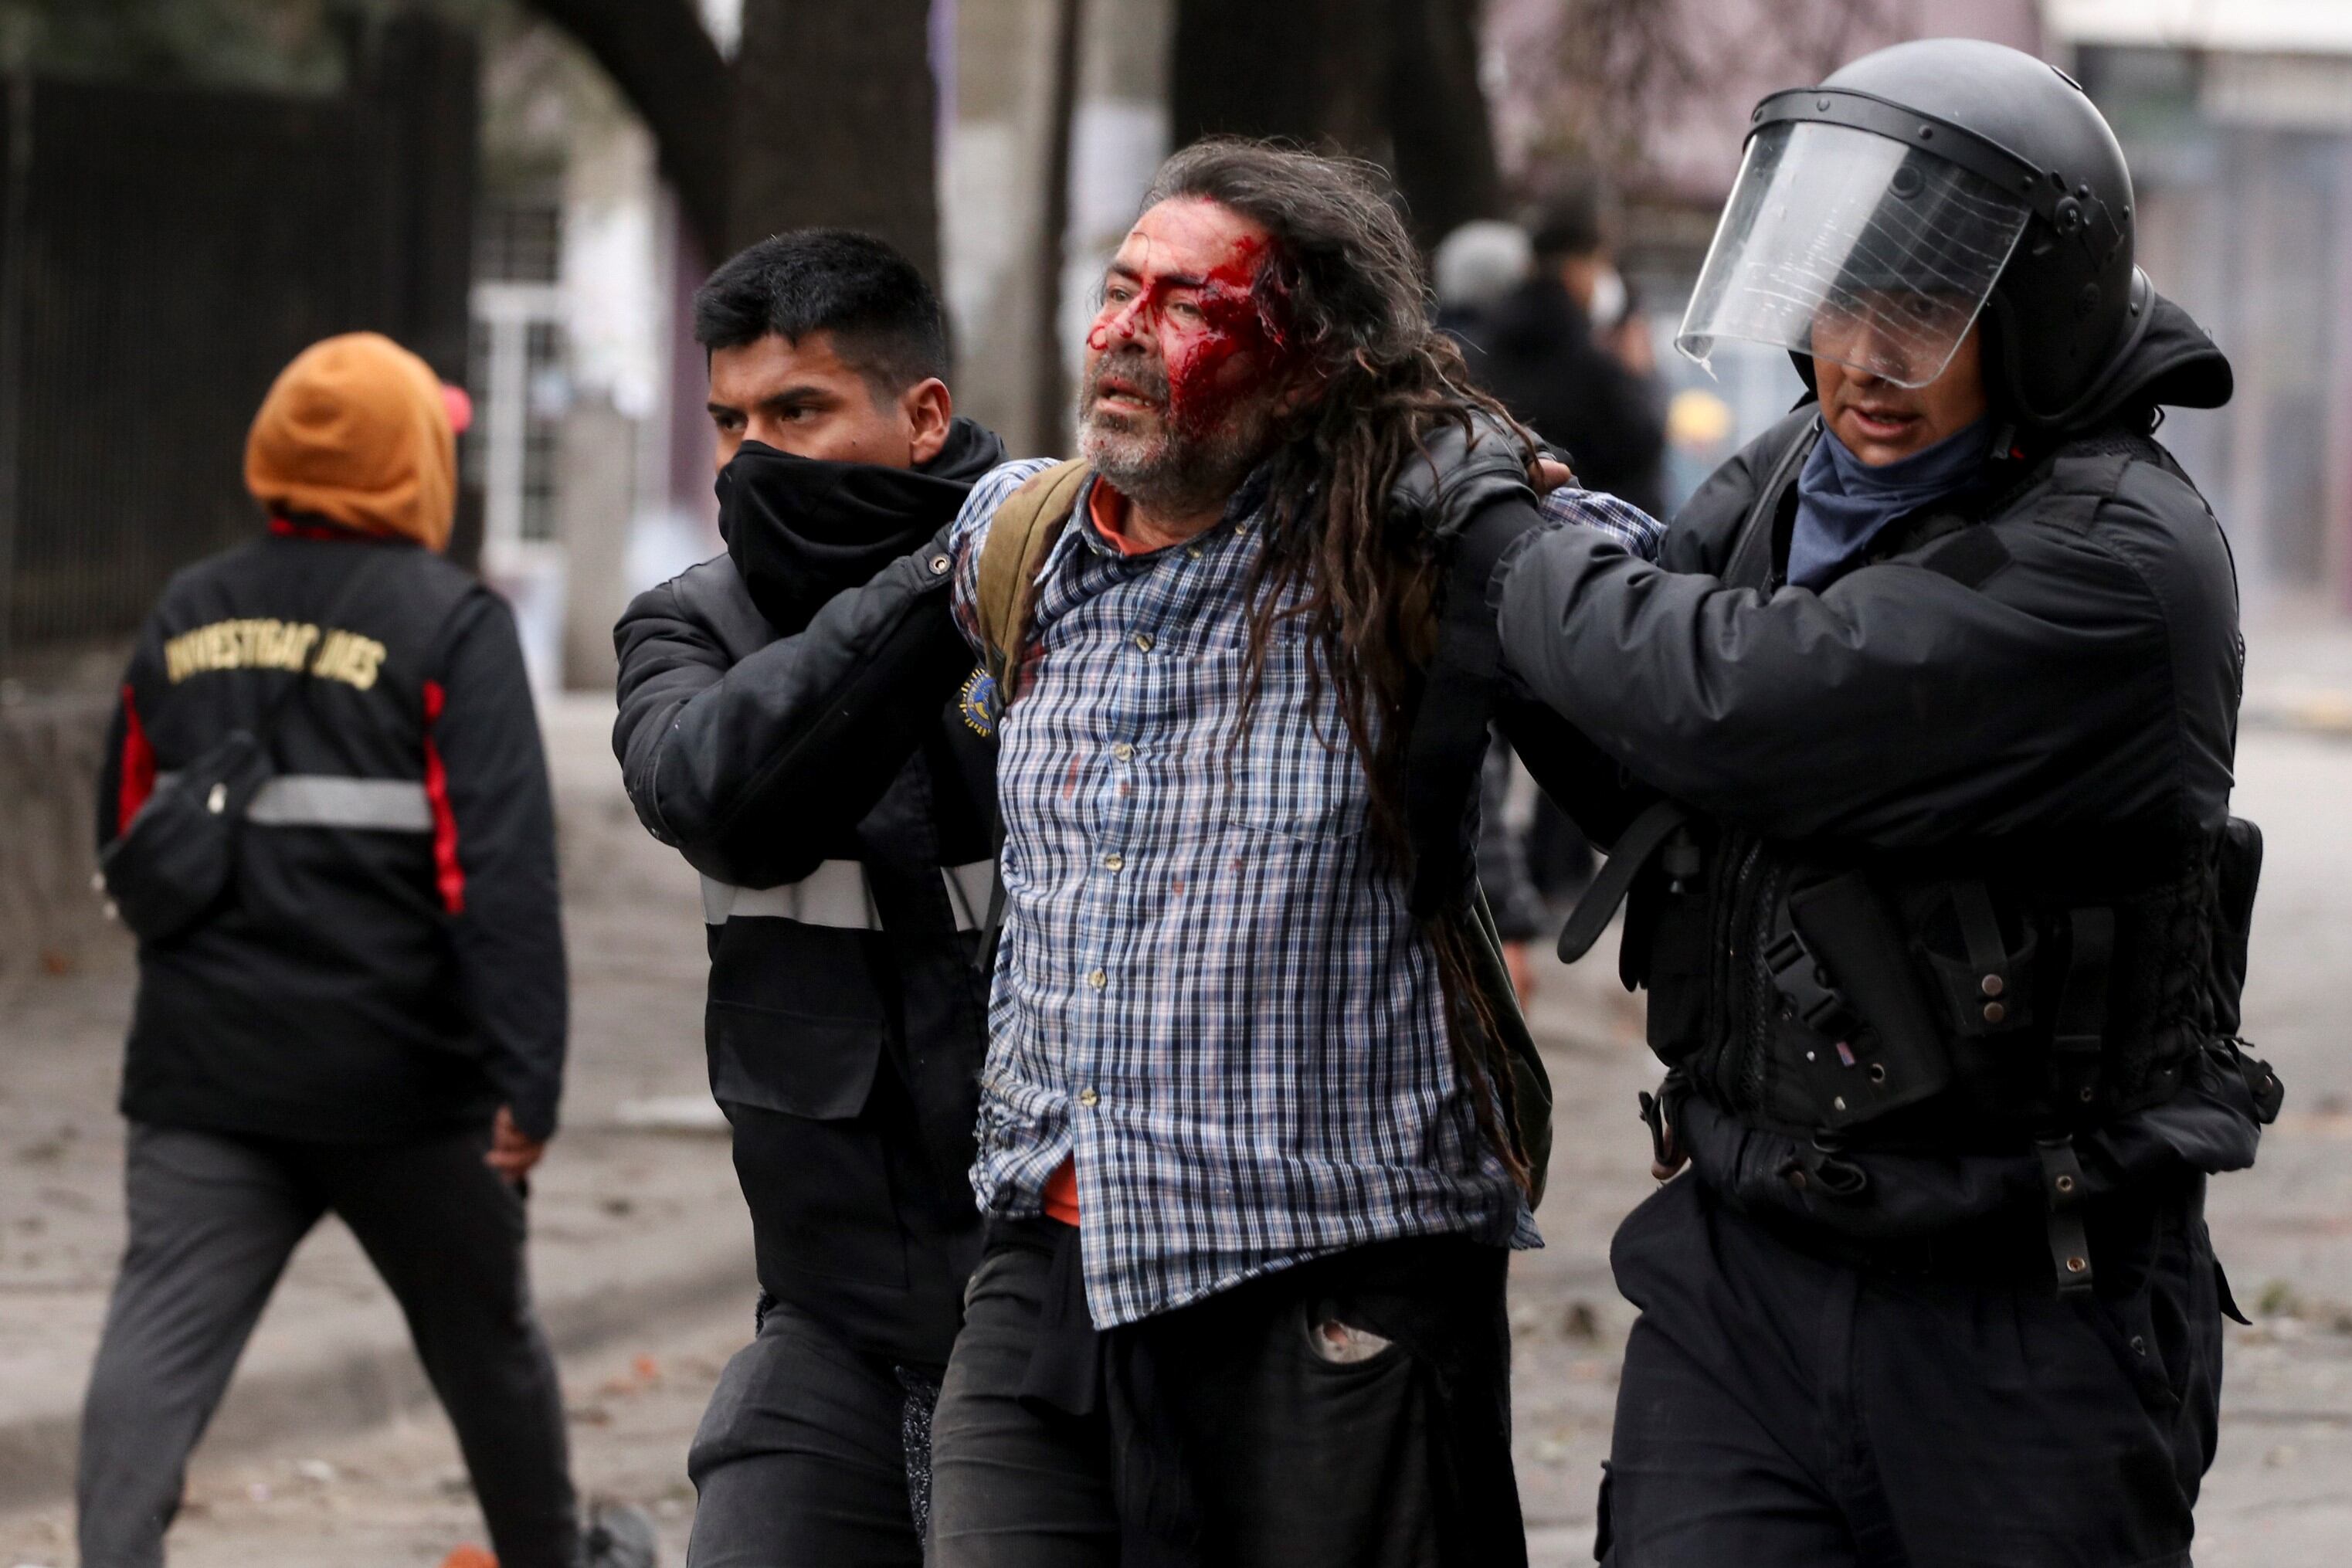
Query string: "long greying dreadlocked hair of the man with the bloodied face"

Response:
xmin=1143 ymin=137 xmax=1533 ymax=1190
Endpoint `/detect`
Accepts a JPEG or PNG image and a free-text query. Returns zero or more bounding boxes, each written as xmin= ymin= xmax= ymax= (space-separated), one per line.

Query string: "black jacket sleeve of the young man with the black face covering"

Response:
xmin=614 ymin=531 xmax=972 ymax=886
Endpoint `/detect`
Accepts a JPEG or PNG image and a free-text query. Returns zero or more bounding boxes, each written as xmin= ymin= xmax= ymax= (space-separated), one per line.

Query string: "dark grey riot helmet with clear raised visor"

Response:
xmin=1675 ymin=38 xmax=2152 ymax=426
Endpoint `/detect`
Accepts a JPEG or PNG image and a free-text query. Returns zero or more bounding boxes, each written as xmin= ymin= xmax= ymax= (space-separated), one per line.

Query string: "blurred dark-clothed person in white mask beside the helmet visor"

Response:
xmin=1479 ymin=183 xmax=1665 ymax=518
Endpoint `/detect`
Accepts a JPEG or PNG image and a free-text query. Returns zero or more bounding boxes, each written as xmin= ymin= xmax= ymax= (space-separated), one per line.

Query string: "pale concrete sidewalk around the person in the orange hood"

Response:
xmin=0 ymin=698 xmax=755 ymax=1505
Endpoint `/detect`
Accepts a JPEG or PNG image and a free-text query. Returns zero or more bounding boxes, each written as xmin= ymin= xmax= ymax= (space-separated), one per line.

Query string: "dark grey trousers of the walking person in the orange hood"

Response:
xmin=75 ymin=1122 xmax=579 ymax=1568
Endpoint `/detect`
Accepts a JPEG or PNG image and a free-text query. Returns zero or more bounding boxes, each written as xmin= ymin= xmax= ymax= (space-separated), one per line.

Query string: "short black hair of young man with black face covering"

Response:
xmin=694 ymin=228 xmax=948 ymax=397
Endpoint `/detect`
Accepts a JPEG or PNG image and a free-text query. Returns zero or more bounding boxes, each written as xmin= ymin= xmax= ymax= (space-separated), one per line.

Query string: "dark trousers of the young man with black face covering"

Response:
xmin=687 ymin=1302 xmax=938 ymax=1568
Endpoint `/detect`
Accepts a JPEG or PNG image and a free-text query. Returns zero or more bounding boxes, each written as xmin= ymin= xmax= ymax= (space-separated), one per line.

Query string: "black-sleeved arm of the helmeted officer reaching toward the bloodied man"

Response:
xmin=1496 ymin=529 xmax=2174 ymax=844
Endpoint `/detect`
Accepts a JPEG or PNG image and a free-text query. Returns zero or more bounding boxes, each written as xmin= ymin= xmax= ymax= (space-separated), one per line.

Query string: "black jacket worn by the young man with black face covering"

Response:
xmin=614 ymin=421 xmax=1002 ymax=1363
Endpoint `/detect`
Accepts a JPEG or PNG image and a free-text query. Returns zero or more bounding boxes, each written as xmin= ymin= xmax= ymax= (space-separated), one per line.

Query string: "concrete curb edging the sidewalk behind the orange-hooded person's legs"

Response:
xmin=0 ymin=1248 xmax=755 ymax=1509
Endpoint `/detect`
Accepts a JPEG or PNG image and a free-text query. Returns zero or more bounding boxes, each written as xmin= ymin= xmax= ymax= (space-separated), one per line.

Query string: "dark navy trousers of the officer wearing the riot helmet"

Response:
xmin=1597 ymin=1176 xmax=2225 ymax=1568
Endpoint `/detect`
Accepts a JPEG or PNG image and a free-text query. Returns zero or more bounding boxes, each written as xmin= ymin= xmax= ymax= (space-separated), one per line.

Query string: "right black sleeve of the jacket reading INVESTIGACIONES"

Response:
xmin=428 ymin=590 xmax=567 ymax=1138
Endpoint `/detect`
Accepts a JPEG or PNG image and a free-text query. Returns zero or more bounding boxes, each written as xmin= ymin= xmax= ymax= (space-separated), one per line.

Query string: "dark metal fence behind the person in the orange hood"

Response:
xmin=0 ymin=16 xmax=473 ymax=674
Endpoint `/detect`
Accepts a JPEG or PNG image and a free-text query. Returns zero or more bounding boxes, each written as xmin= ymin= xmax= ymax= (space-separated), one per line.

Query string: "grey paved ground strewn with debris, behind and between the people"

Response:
xmin=0 ymin=705 xmax=2352 ymax=1568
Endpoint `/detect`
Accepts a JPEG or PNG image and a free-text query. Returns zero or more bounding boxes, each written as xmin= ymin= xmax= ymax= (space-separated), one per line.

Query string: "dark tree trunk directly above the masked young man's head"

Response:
xmin=727 ymin=0 xmax=938 ymax=280
